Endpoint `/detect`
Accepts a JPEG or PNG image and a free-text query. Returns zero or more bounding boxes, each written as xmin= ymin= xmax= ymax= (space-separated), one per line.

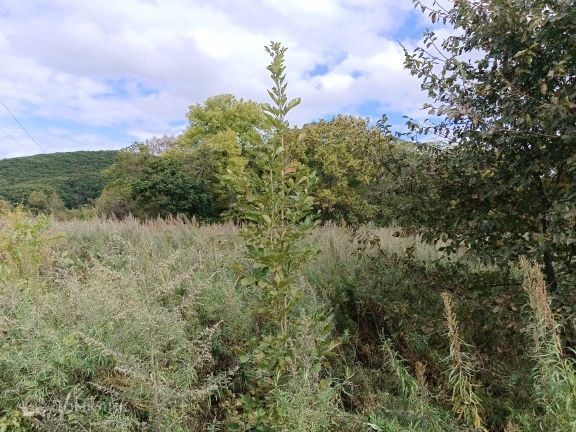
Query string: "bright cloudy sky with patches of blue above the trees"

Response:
xmin=0 ymin=0 xmax=434 ymax=158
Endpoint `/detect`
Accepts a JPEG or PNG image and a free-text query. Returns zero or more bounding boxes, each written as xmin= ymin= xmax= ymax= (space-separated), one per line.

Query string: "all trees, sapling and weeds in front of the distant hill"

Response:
xmin=0 ymin=0 xmax=576 ymax=432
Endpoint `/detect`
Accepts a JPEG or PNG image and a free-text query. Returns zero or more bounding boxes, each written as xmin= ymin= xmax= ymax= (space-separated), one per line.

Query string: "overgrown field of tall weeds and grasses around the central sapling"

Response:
xmin=0 ymin=210 xmax=576 ymax=431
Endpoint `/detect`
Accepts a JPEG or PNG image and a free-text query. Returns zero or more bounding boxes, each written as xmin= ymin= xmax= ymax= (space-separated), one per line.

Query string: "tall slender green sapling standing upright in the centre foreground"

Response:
xmin=227 ymin=42 xmax=335 ymax=431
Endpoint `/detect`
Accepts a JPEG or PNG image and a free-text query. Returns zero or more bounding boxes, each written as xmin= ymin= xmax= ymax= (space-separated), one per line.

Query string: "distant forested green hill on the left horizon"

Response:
xmin=0 ymin=150 xmax=117 ymax=208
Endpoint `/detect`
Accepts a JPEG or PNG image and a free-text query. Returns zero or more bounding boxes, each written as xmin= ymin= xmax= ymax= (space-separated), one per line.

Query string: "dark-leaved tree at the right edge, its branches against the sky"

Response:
xmin=405 ymin=0 xmax=576 ymax=289
